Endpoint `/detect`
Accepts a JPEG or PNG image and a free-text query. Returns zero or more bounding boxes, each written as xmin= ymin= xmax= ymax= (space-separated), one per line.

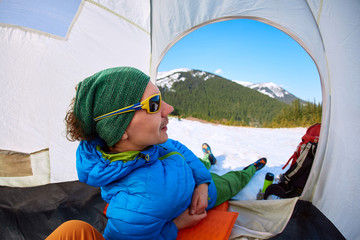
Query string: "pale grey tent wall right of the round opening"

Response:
xmin=306 ymin=1 xmax=360 ymax=239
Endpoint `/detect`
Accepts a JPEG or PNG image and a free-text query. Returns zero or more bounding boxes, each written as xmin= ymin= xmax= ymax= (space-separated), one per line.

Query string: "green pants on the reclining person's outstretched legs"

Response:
xmin=199 ymin=154 xmax=256 ymax=206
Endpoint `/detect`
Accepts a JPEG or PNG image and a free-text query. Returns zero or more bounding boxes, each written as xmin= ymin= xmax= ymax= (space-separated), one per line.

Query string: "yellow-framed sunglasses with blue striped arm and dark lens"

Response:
xmin=94 ymin=93 xmax=161 ymax=122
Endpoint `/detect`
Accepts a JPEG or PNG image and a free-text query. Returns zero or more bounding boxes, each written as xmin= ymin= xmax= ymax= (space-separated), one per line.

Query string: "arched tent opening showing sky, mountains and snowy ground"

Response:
xmin=156 ymin=19 xmax=322 ymax=200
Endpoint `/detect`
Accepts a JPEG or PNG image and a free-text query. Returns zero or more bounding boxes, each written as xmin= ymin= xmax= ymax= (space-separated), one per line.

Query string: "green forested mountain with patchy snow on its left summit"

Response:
xmin=156 ymin=69 xmax=286 ymax=126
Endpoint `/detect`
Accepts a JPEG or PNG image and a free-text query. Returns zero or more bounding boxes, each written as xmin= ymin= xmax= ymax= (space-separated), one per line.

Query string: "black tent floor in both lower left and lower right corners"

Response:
xmin=0 ymin=181 xmax=345 ymax=240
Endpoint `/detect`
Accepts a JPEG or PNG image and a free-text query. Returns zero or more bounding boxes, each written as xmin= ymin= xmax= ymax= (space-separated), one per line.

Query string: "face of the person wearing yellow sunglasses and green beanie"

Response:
xmin=125 ymin=81 xmax=174 ymax=150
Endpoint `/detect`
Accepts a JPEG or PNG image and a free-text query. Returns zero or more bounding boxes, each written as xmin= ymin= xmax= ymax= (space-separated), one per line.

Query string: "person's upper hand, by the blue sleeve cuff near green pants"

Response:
xmin=190 ymin=183 xmax=209 ymax=215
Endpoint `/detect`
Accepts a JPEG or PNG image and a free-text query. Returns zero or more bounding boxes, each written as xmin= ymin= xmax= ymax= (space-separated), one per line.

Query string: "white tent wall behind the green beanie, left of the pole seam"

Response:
xmin=0 ymin=1 xmax=150 ymax=182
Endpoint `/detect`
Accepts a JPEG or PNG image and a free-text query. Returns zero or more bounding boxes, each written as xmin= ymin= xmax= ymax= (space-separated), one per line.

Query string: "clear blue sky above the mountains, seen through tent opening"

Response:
xmin=158 ymin=19 xmax=321 ymax=102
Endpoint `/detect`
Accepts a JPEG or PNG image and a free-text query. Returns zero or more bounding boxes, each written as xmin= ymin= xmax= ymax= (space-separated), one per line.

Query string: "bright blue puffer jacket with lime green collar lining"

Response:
xmin=76 ymin=139 xmax=216 ymax=240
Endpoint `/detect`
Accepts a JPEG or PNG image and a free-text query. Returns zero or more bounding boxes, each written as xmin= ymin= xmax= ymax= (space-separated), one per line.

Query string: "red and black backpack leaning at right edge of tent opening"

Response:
xmin=264 ymin=123 xmax=321 ymax=199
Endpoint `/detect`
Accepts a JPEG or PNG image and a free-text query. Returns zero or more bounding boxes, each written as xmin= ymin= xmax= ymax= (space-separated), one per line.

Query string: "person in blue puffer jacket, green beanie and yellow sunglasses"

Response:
xmin=50 ymin=67 xmax=266 ymax=239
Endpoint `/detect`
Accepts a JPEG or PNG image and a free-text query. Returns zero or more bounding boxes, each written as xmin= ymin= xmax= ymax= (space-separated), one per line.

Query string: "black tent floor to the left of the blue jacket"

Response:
xmin=0 ymin=181 xmax=107 ymax=240
